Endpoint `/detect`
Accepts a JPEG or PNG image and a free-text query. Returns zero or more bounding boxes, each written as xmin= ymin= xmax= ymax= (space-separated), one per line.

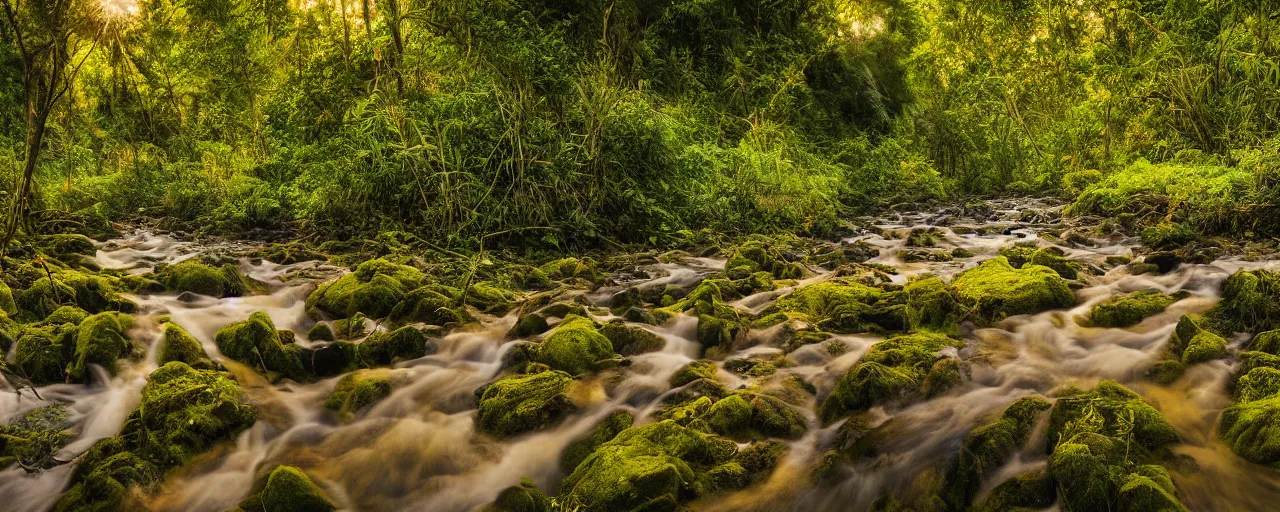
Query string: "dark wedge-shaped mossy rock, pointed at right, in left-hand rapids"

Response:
xmin=214 ymin=311 xmax=311 ymax=381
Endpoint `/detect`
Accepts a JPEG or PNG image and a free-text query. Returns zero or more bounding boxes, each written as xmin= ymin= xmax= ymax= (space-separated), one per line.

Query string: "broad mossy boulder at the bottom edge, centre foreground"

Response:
xmin=561 ymin=421 xmax=737 ymax=511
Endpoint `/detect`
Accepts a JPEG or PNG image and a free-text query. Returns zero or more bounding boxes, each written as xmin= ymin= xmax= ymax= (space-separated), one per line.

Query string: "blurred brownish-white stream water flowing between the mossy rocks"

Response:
xmin=0 ymin=202 xmax=1280 ymax=512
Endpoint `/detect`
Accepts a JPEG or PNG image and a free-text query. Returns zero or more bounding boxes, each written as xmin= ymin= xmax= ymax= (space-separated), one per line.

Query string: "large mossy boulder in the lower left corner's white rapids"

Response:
xmin=120 ymin=362 xmax=255 ymax=467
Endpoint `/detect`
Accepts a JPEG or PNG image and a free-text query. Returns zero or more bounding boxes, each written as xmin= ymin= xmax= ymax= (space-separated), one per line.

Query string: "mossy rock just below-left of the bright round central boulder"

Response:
xmin=477 ymin=371 xmax=576 ymax=438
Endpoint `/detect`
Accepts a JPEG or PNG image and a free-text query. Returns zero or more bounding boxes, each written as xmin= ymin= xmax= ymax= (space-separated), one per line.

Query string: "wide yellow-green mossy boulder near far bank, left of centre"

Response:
xmin=306 ymin=259 xmax=425 ymax=319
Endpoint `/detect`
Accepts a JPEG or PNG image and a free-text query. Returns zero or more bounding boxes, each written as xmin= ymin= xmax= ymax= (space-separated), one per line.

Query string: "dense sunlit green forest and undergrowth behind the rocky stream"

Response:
xmin=0 ymin=0 xmax=1280 ymax=248
